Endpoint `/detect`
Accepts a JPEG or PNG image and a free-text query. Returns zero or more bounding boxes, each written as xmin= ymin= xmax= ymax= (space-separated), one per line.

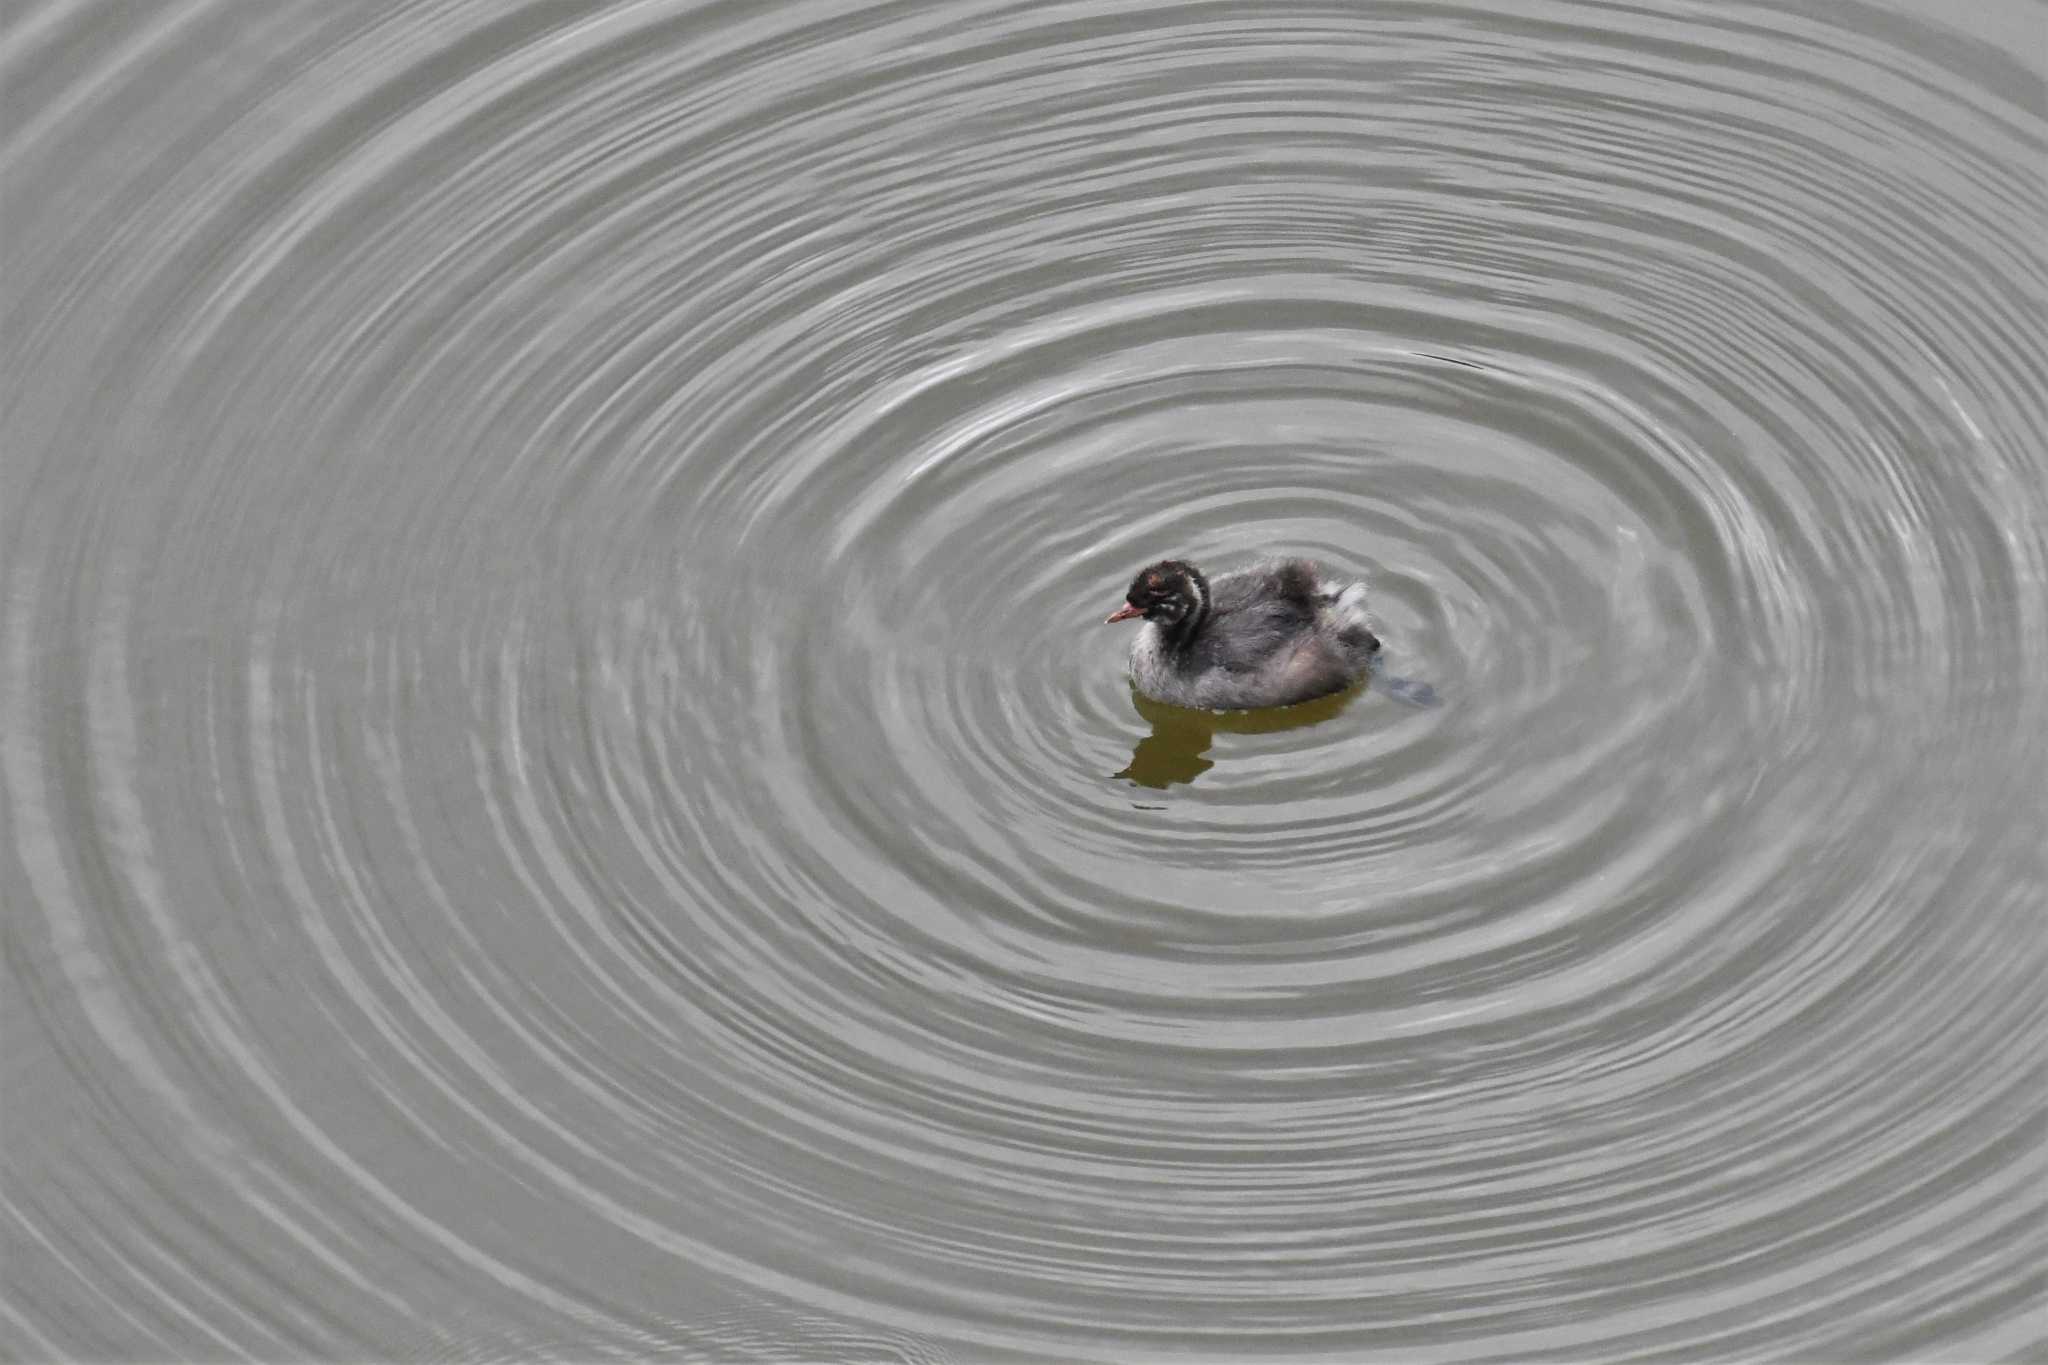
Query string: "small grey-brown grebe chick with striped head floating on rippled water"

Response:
xmin=1110 ymin=559 xmax=1380 ymax=710
